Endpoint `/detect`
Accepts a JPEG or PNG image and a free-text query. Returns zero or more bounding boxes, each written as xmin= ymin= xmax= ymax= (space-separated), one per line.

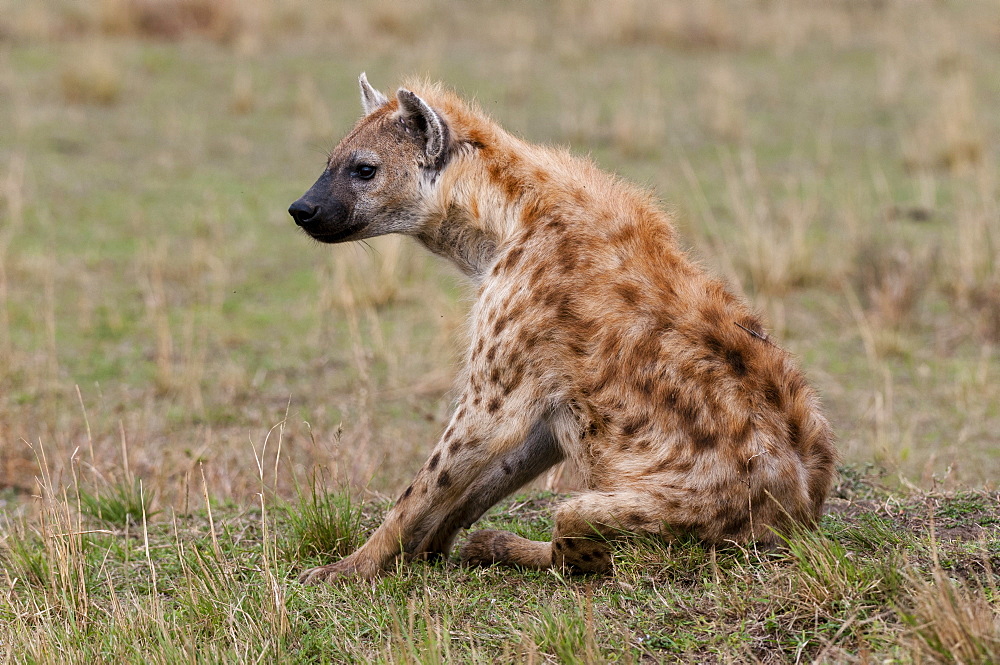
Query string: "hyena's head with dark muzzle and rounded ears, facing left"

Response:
xmin=288 ymin=74 xmax=449 ymax=243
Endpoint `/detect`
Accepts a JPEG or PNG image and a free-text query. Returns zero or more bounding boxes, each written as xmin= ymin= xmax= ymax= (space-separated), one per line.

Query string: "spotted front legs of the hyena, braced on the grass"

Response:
xmin=299 ymin=399 xmax=562 ymax=583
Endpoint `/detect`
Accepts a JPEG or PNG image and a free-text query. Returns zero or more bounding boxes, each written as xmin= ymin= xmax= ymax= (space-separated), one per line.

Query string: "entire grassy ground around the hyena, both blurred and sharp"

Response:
xmin=0 ymin=0 xmax=1000 ymax=662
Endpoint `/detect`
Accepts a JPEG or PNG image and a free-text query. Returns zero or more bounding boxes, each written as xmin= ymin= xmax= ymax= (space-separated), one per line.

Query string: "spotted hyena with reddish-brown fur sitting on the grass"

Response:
xmin=289 ymin=74 xmax=836 ymax=582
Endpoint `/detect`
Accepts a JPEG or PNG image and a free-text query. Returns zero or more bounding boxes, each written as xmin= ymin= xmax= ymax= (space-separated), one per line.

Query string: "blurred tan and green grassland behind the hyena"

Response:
xmin=0 ymin=0 xmax=1000 ymax=514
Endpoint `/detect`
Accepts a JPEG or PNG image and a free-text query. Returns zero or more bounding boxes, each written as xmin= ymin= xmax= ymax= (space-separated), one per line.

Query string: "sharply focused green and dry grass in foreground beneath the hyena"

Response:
xmin=0 ymin=472 xmax=1000 ymax=663
